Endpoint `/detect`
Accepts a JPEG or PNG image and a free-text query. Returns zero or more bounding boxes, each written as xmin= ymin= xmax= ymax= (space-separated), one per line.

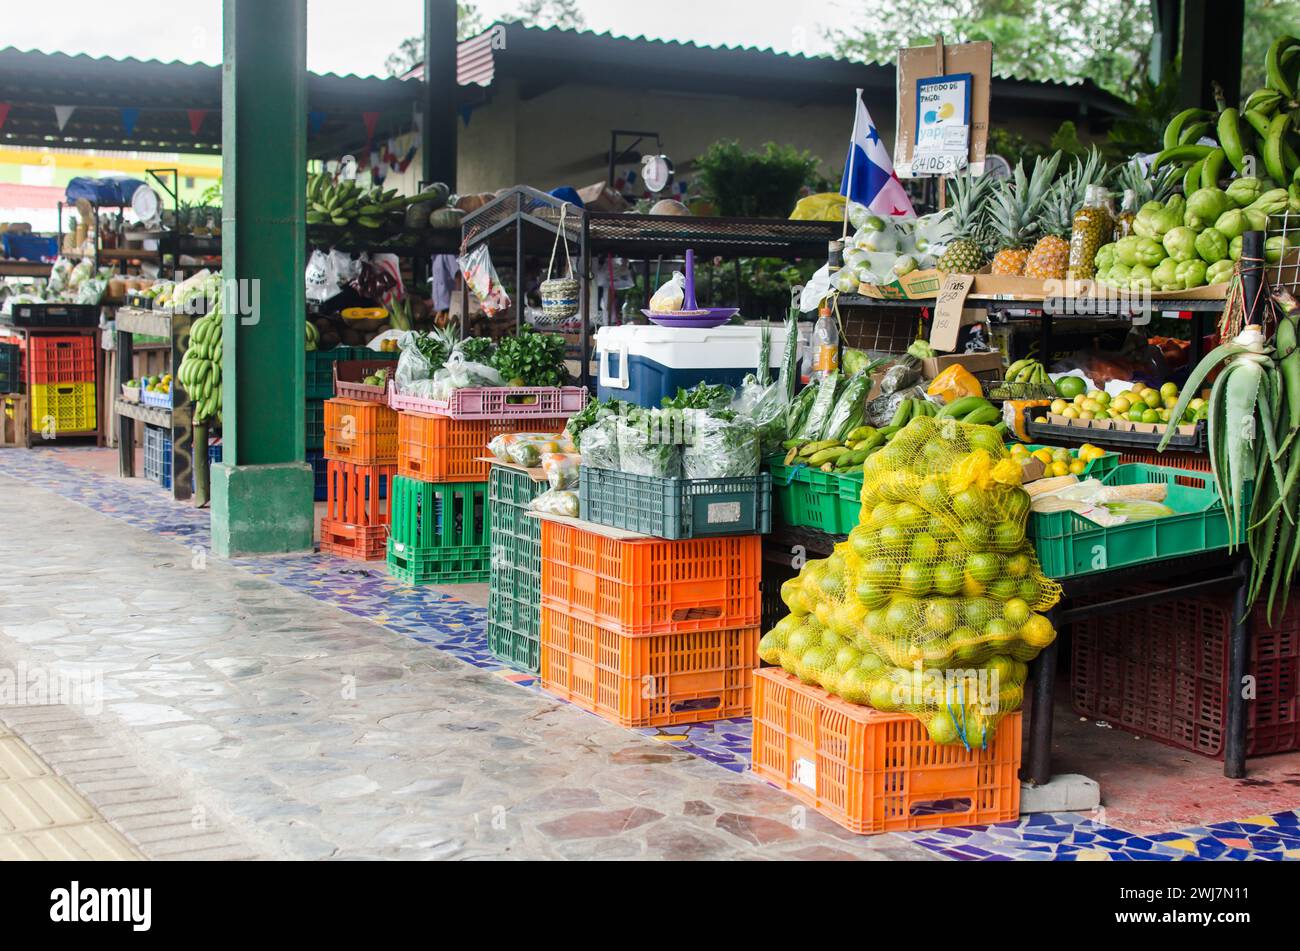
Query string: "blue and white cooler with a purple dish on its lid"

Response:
xmin=595 ymin=323 xmax=785 ymax=407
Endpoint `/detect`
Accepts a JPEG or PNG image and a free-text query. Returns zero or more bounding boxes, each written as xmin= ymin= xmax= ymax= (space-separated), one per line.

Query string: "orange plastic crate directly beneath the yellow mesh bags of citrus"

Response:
xmin=754 ymin=670 xmax=1021 ymax=834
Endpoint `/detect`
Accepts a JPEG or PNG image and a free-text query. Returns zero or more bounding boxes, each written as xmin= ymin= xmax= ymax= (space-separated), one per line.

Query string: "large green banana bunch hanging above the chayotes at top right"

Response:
xmin=1152 ymin=36 xmax=1300 ymax=201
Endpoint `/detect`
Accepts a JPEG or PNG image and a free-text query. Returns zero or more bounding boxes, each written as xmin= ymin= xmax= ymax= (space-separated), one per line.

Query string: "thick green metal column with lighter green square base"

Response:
xmin=212 ymin=0 xmax=315 ymax=557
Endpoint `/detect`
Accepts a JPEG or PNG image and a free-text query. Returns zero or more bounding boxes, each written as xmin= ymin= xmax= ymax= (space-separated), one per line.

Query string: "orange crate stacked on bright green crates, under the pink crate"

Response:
xmin=389 ymin=413 xmax=568 ymax=589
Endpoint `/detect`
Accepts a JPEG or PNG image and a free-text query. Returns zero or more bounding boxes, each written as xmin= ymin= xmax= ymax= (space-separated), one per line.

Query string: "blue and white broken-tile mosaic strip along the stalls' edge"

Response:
xmin=0 ymin=447 xmax=1300 ymax=861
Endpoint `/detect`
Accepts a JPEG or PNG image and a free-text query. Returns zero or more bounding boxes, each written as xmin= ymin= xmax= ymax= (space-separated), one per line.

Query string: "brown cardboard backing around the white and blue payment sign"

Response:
xmin=894 ymin=40 xmax=993 ymax=178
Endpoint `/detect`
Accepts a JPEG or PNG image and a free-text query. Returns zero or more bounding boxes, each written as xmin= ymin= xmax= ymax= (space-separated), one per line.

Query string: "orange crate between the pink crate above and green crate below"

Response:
xmin=398 ymin=412 xmax=568 ymax=482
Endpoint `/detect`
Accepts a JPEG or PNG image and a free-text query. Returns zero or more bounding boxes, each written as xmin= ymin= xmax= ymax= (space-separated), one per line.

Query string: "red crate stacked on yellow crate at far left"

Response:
xmin=26 ymin=335 xmax=99 ymax=435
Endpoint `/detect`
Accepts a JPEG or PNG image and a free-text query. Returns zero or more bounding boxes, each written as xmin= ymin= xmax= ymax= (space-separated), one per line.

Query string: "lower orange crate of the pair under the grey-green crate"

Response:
xmin=541 ymin=602 xmax=761 ymax=726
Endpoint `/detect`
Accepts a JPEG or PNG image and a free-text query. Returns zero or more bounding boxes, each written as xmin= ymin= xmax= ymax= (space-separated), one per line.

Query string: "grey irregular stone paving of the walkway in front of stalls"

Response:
xmin=0 ymin=476 xmax=937 ymax=859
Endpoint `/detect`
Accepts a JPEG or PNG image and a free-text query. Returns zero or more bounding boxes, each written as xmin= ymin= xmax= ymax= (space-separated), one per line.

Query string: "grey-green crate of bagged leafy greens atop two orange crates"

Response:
xmin=579 ymin=465 xmax=772 ymax=542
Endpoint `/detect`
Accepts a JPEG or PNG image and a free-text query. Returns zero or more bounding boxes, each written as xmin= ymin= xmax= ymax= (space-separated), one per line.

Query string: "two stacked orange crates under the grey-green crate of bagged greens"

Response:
xmin=541 ymin=517 xmax=762 ymax=728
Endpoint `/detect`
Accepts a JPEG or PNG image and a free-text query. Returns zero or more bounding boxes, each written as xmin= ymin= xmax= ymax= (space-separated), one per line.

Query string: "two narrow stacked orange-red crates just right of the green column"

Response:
xmin=321 ymin=399 xmax=398 ymax=561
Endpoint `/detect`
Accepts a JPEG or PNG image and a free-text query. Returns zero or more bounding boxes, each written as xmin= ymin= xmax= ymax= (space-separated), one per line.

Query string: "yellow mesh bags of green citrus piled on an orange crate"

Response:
xmin=759 ymin=418 xmax=1061 ymax=748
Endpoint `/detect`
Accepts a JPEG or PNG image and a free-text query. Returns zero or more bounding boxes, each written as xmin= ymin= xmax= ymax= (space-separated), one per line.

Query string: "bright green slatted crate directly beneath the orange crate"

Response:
xmin=391 ymin=476 xmax=490 ymax=551
